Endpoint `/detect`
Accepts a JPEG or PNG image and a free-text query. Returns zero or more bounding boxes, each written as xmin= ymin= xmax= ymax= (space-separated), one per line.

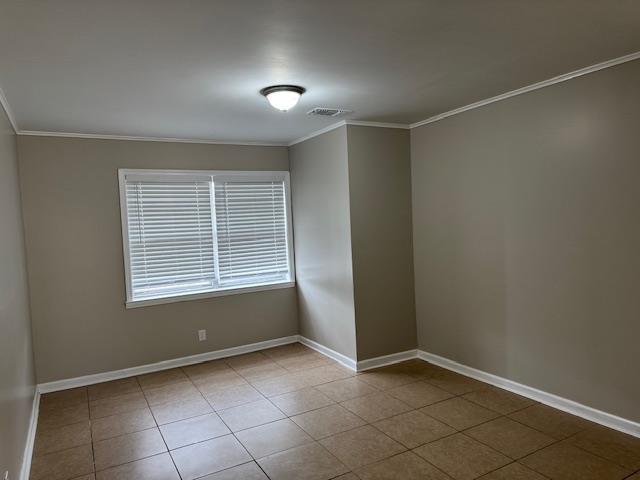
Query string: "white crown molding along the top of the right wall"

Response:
xmin=409 ymin=48 xmax=640 ymax=129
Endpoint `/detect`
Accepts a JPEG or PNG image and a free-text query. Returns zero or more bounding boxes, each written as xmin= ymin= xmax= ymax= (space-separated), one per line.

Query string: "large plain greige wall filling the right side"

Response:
xmin=411 ymin=61 xmax=640 ymax=421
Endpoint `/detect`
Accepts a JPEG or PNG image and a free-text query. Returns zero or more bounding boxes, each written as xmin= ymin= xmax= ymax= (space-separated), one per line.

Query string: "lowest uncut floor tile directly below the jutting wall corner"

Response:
xmin=320 ymin=425 xmax=406 ymax=470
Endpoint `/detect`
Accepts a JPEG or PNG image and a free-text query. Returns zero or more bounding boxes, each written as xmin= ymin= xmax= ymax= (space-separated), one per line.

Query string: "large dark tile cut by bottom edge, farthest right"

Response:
xmin=520 ymin=442 xmax=632 ymax=480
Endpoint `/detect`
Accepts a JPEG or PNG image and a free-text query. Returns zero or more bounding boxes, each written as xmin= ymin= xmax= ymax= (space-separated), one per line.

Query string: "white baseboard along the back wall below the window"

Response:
xmin=38 ymin=335 xmax=298 ymax=393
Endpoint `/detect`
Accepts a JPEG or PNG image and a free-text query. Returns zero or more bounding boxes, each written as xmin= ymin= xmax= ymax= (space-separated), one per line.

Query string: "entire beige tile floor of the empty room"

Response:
xmin=31 ymin=344 xmax=640 ymax=480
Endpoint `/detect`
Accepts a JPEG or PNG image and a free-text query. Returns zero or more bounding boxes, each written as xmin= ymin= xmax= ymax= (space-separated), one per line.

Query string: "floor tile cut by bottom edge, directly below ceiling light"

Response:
xmin=258 ymin=443 xmax=348 ymax=480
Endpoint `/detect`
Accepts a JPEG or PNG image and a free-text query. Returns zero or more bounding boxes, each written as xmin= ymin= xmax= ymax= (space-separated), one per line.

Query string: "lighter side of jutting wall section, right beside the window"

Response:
xmin=289 ymin=126 xmax=357 ymax=360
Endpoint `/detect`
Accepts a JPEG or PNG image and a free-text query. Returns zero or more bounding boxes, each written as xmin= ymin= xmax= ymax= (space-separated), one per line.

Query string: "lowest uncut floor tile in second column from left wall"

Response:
xmin=93 ymin=428 xmax=167 ymax=471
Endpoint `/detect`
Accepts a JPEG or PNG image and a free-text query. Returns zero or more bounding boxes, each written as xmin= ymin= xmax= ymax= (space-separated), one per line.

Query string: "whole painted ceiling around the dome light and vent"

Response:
xmin=0 ymin=0 xmax=640 ymax=143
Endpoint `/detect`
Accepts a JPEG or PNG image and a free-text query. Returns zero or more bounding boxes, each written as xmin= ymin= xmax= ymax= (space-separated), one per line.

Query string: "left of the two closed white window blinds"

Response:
xmin=127 ymin=181 xmax=215 ymax=299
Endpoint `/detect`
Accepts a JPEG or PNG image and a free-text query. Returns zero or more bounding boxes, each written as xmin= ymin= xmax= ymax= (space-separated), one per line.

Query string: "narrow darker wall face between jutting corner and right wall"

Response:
xmin=347 ymin=125 xmax=417 ymax=360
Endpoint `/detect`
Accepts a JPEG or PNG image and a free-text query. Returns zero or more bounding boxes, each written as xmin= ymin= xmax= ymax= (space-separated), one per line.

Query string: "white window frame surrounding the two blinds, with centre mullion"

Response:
xmin=118 ymin=168 xmax=296 ymax=309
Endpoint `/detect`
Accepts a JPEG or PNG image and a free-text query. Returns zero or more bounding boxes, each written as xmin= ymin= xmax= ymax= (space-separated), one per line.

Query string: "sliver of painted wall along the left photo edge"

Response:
xmin=0 ymin=107 xmax=35 ymax=479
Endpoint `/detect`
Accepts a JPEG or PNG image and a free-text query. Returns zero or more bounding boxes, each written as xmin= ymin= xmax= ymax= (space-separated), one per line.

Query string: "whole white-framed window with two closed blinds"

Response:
xmin=119 ymin=170 xmax=294 ymax=307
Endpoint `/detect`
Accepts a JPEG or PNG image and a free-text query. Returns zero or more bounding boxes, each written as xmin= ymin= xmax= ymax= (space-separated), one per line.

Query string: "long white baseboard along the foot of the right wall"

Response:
xmin=418 ymin=350 xmax=640 ymax=437
